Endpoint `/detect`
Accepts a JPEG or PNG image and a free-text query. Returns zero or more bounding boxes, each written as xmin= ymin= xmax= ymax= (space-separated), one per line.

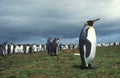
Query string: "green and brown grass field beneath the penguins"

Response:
xmin=0 ymin=46 xmax=120 ymax=78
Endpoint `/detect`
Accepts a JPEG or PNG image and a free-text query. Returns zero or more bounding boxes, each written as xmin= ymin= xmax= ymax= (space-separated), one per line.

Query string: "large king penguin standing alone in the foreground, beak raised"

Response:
xmin=79 ymin=18 xmax=100 ymax=69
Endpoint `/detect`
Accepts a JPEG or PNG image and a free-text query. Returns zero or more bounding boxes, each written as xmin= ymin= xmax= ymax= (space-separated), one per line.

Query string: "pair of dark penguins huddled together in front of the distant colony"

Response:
xmin=46 ymin=37 xmax=59 ymax=56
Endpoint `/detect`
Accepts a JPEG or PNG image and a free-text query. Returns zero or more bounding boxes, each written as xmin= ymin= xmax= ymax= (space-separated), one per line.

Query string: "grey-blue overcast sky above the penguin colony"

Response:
xmin=0 ymin=0 xmax=120 ymax=43
